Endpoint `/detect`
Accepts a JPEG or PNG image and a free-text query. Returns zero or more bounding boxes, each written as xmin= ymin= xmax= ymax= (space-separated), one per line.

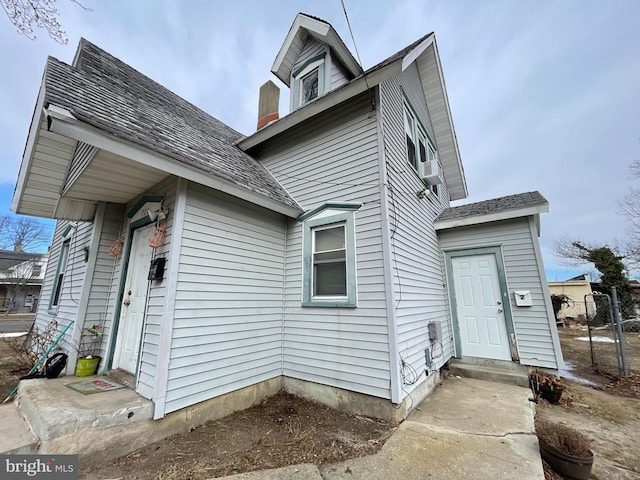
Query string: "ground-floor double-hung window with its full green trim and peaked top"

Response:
xmin=302 ymin=207 xmax=357 ymax=307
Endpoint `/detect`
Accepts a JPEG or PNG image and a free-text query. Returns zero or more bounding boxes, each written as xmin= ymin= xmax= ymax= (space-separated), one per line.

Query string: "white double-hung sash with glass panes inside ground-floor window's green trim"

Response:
xmin=313 ymin=223 xmax=347 ymax=297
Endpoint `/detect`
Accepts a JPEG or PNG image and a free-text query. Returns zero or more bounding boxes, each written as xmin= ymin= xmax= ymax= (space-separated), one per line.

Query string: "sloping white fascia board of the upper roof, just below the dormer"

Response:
xmin=235 ymin=61 xmax=401 ymax=152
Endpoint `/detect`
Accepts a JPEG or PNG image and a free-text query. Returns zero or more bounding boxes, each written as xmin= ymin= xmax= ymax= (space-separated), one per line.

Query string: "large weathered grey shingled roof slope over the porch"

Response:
xmin=45 ymin=39 xmax=302 ymax=211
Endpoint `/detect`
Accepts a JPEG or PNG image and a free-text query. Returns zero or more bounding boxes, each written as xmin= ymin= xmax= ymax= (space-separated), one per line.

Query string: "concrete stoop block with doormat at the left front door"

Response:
xmin=17 ymin=376 xmax=153 ymax=442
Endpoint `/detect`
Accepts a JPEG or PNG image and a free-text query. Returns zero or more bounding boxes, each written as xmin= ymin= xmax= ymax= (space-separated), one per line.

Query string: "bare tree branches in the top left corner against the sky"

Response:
xmin=0 ymin=0 xmax=90 ymax=44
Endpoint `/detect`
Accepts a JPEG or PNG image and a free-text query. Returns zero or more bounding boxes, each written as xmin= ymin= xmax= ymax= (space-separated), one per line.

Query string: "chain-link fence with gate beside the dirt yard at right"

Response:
xmin=584 ymin=288 xmax=640 ymax=379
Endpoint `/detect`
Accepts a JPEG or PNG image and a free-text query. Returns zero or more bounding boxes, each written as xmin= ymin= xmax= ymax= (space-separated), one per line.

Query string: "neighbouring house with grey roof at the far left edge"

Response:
xmin=0 ymin=250 xmax=48 ymax=313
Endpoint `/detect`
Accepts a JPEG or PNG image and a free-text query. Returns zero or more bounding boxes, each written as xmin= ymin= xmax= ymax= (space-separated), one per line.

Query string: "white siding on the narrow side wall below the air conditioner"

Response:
xmin=380 ymin=67 xmax=453 ymax=393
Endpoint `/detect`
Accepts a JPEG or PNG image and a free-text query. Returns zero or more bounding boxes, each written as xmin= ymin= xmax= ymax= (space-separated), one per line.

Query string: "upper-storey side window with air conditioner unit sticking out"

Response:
xmin=403 ymin=102 xmax=442 ymax=195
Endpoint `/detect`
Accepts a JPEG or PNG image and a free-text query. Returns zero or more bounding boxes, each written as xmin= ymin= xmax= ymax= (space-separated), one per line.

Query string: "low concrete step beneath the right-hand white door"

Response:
xmin=449 ymin=357 xmax=529 ymax=387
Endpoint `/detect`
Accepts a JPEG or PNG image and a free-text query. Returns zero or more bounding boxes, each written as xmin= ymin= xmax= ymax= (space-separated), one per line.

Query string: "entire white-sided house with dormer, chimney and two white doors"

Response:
xmin=12 ymin=14 xmax=562 ymax=418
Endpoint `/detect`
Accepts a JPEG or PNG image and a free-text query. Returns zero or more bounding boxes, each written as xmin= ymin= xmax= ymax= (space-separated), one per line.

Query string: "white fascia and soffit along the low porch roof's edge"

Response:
xmin=12 ymin=104 xmax=301 ymax=221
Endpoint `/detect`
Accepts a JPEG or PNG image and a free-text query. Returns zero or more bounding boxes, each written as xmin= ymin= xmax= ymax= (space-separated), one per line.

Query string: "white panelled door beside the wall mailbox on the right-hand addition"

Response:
xmin=451 ymin=254 xmax=511 ymax=360
